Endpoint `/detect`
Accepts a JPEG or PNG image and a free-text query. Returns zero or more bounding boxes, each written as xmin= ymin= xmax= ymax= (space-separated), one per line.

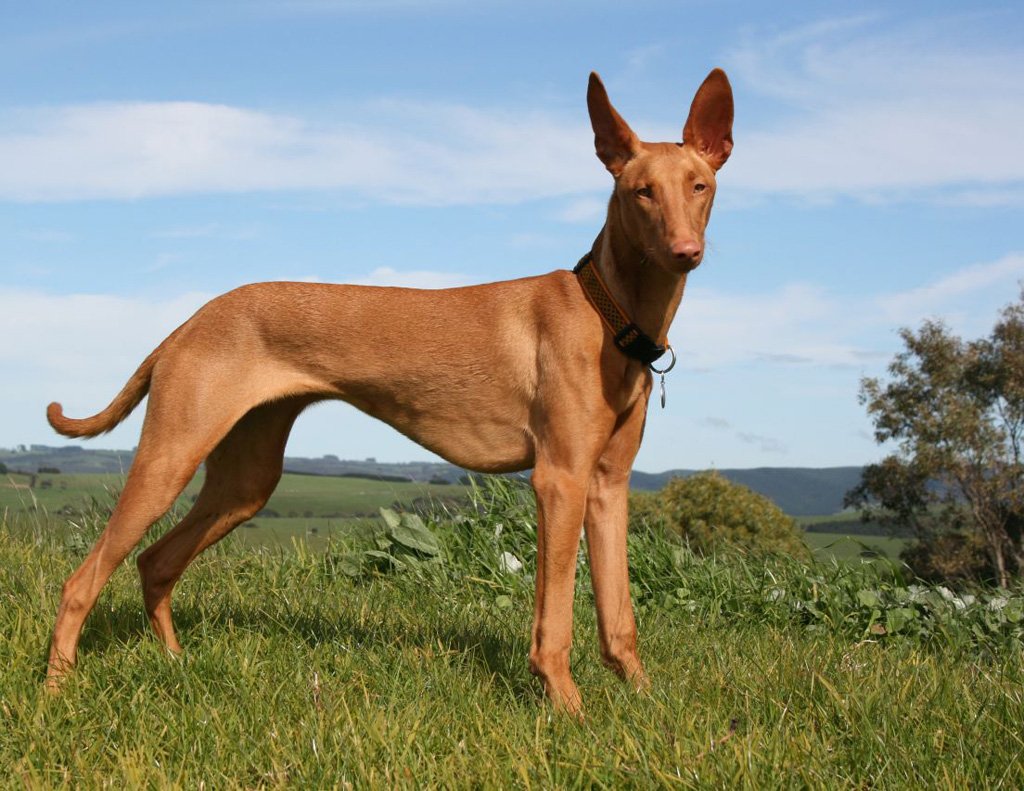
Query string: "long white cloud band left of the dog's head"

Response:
xmin=0 ymin=101 xmax=607 ymax=205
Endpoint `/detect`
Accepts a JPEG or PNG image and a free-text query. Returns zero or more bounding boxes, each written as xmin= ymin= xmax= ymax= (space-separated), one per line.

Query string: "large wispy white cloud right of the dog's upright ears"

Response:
xmin=728 ymin=17 xmax=1024 ymax=205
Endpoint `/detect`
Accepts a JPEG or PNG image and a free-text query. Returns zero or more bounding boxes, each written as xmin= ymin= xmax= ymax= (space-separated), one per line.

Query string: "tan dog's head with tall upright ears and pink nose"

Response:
xmin=587 ymin=69 xmax=732 ymax=274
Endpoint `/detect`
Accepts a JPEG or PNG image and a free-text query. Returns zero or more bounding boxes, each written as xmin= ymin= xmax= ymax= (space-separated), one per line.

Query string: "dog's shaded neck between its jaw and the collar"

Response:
xmin=591 ymin=197 xmax=686 ymax=344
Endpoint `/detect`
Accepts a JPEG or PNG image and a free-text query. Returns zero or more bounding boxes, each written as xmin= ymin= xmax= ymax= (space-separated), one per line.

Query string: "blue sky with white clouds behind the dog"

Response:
xmin=0 ymin=0 xmax=1024 ymax=471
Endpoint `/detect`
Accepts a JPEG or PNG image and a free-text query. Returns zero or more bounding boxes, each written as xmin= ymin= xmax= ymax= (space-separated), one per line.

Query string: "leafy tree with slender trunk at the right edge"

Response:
xmin=847 ymin=291 xmax=1024 ymax=586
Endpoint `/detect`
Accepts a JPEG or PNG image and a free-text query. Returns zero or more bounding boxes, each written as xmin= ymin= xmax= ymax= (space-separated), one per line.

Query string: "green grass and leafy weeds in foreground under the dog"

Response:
xmin=0 ymin=479 xmax=1024 ymax=789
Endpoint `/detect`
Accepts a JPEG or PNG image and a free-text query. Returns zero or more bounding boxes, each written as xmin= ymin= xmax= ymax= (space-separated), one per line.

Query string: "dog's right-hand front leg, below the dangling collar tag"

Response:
xmin=585 ymin=398 xmax=648 ymax=690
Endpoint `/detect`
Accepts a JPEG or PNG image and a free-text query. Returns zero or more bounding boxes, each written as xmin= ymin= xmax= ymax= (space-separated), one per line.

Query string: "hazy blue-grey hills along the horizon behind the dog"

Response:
xmin=0 ymin=445 xmax=861 ymax=516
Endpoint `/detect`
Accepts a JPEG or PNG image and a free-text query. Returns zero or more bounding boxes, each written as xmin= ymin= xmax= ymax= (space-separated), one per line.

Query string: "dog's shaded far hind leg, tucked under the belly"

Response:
xmin=137 ymin=397 xmax=313 ymax=652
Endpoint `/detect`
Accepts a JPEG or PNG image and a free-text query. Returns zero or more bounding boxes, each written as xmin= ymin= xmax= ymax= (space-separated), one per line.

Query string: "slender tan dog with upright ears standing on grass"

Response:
xmin=47 ymin=70 xmax=732 ymax=712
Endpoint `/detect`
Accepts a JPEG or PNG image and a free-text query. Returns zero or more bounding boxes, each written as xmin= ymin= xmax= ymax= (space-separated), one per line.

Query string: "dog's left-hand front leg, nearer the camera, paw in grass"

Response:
xmin=529 ymin=461 xmax=586 ymax=715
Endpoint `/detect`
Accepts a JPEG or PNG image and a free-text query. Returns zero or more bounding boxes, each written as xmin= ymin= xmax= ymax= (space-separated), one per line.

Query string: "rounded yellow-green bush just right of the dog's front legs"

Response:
xmin=630 ymin=471 xmax=807 ymax=556
